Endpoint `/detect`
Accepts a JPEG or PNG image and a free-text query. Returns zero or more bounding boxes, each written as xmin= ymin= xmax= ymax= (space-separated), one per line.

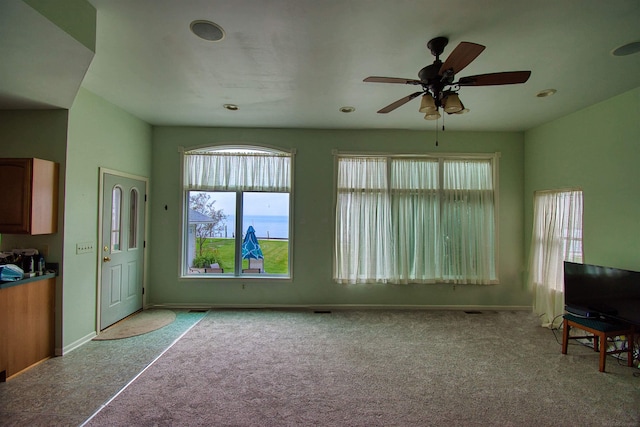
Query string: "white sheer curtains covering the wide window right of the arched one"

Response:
xmin=334 ymin=155 xmax=497 ymax=284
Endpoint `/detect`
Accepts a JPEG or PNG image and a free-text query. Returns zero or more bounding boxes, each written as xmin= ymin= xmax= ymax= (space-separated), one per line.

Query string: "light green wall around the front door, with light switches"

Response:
xmin=62 ymin=88 xmax=151 ymax=348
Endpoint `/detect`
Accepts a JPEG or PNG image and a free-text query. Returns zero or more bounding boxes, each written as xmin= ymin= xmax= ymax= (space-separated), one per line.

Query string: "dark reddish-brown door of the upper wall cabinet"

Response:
xmin=0 ymin=159 xmax=33 ymax=234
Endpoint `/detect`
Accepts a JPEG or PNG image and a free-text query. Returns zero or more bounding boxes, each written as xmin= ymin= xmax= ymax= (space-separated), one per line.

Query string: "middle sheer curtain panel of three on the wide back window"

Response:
xmin=391 ymin=159 xmax=441 ymax=283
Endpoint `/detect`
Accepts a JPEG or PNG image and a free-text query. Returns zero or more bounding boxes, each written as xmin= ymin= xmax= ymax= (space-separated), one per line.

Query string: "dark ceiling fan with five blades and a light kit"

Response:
xmin=364 ymin=37 xmax=531 ymax=120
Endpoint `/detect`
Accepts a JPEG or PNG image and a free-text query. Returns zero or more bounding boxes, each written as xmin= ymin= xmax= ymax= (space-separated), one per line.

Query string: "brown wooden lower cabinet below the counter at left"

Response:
xmin=0 ymin=277 xmax=56 ymax=381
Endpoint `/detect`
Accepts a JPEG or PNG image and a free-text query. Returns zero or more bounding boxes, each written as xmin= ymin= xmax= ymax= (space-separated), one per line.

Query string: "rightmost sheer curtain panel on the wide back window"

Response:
xmin=442 ymin=159 xmax=497 ymax=284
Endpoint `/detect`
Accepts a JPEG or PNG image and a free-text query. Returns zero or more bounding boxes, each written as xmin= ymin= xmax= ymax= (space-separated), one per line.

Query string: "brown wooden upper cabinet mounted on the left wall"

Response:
xmin=0 ymin=159 xmax=59 ymax=234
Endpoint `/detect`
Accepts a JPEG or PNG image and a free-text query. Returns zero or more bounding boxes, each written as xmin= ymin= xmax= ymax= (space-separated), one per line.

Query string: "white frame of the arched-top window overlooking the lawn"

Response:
xmin=178 ymin=143 xmax=296 ymax=281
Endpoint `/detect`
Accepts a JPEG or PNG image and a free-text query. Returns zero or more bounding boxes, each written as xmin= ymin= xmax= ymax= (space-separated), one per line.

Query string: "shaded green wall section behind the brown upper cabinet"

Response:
xmin=0 ymin=110 xmax=68 ymax=348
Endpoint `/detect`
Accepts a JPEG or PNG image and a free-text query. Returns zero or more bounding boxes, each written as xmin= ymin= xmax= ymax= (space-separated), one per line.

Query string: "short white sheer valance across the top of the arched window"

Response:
xmin=183 ymin=152 xmax=291 ymax=192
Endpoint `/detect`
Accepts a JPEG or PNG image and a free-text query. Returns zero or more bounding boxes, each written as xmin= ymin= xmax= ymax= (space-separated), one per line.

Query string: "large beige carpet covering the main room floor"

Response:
xmin=84 ymin=310 xmax=640 ymax=427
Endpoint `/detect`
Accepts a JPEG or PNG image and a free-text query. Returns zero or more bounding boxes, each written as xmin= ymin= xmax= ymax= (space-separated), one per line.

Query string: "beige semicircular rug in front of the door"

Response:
xmin=94 ymin=309 xmax=176 ymax=341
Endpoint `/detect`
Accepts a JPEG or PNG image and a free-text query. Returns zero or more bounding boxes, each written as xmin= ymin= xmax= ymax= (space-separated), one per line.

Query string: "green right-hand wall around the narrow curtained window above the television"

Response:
xmin=524 ymin=88 xmax=640 ymax=271
